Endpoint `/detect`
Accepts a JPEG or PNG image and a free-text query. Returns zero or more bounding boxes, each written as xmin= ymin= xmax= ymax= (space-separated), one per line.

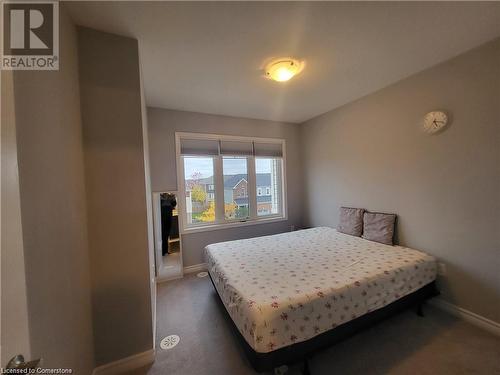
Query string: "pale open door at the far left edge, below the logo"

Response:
xmin=0 ymin=70 xmax=31 ymax=364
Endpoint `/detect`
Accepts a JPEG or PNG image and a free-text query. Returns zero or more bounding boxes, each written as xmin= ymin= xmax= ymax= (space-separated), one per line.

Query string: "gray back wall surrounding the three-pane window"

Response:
xmin=148 ymin=108 xmax=303 ymax=266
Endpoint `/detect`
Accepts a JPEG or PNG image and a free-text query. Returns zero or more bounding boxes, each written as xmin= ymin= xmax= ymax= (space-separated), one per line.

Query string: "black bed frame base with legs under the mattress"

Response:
xmin=209 ymin=273 xmax=439 ymax=375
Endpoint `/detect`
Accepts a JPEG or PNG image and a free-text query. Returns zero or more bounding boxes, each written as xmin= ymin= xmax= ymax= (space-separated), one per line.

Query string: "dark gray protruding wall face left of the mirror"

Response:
xmin=78 ymin=28 xmax=153 ymax=365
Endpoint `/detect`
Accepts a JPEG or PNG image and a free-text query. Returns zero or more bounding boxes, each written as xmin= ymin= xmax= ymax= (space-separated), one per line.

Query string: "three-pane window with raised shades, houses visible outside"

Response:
xmin=176 ymin=133 xmax=286 ymax=230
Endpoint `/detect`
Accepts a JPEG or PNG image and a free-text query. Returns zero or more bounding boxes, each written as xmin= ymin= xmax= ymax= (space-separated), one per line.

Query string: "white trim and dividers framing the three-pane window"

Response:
xmin=175 ymin=132 xmax=288 ymax=234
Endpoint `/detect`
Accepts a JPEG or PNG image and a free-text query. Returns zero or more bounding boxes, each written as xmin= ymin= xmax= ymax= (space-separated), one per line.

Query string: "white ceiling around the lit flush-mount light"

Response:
xmin=68 ymin=2 xmax=500 ymax=122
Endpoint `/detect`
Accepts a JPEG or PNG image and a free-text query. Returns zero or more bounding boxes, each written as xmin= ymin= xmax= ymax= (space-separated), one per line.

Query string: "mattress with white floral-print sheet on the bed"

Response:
xmin=205 ymin=227 xmax=437 ymax=353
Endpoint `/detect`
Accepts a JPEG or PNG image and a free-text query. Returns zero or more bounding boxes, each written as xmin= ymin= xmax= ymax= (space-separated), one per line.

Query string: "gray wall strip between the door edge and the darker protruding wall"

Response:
xmin=7 ymin=6 xmax=94 ymax=374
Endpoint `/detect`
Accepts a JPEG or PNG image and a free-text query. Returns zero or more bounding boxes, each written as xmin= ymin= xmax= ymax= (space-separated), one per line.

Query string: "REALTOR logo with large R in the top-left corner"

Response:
xmin=0 ymin=1 xmax=59 ymax=70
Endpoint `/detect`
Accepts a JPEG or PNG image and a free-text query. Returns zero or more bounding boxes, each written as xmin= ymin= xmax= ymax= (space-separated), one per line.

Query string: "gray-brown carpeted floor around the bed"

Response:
xmin=130 ymin=274 xmax=500 ymax=375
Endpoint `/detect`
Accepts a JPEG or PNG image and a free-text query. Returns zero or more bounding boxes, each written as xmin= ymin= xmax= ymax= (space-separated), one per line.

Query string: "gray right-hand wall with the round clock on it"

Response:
xmin=301 ymin=39 xmax=500 ymax=322
